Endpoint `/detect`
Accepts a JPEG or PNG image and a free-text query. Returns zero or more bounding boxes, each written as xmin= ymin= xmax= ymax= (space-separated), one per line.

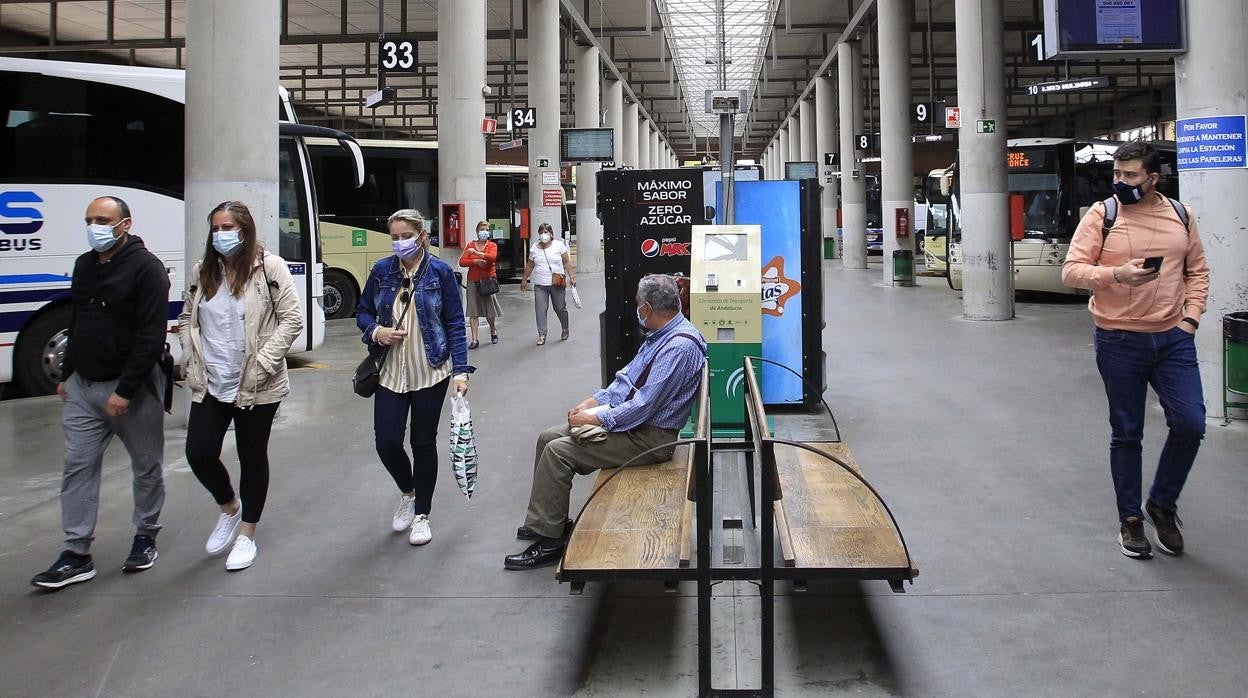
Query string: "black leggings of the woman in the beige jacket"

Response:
xmin=186 ymin=395 xmax=280 ymax=523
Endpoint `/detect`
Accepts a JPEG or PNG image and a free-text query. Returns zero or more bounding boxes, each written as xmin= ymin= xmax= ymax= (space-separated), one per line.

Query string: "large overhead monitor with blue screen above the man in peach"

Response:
xmin=1045 ymin=0 xmax=1187 ymax=59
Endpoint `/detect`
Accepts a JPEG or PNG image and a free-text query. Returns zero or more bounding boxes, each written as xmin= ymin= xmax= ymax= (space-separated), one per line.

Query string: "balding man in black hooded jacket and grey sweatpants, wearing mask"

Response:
xmin=31 ymin=196 xmax=168 ymax=589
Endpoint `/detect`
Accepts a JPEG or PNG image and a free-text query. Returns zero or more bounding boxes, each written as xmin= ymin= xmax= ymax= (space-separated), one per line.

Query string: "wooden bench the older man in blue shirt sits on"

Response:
xmin=555 ymin=365 xmax=710 ymax=593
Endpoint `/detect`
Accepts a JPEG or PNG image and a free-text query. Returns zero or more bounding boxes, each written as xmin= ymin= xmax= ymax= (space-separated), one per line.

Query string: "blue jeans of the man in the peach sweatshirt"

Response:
xmin=1096 ymin=327 xmax=1204 ymax=521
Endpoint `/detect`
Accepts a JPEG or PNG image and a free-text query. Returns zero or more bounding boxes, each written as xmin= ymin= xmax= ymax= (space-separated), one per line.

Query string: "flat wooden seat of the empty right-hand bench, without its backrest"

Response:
xmin=775 ymin=442 xmax=907 ymax=569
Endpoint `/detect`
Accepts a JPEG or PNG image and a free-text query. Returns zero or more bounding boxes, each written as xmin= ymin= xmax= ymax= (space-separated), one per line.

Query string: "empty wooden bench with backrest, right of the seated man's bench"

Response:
xmin=745 ymin=360 xmax=919 ymax=591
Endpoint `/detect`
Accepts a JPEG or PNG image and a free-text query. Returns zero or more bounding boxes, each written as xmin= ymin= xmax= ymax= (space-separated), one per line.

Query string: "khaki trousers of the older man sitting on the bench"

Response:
xmin=524 ymin=423 xmax=679 ymax=538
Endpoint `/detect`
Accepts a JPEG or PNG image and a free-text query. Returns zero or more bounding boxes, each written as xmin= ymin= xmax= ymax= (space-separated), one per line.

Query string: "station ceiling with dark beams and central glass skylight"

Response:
xmin=0 ymin=0 xmax=1174 ymax=157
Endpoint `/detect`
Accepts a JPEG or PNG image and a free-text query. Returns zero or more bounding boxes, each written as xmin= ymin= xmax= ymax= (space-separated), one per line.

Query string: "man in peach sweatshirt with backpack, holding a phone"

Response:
xmin=1062 ymin=142 xmax=1209 ymax=559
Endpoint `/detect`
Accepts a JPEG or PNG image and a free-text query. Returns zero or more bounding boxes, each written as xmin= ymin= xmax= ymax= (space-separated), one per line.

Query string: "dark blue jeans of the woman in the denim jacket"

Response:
xmin=373 ymin=378 xmax=451 ymax=514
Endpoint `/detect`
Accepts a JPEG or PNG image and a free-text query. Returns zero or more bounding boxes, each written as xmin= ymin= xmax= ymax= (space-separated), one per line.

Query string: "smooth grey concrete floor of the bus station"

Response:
xmin=0 ymin=262 xmax=1248 ymax=697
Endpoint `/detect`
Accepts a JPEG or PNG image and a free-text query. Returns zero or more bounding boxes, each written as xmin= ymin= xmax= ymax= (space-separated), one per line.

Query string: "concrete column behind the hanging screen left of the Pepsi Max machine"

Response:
xmin=574 ymin=46 xmax=603 ymax=272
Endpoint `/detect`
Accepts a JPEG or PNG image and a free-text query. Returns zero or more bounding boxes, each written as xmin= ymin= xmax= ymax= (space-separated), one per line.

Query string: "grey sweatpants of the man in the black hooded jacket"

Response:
xmin=61 ymin=370 xmax=165 ymax=554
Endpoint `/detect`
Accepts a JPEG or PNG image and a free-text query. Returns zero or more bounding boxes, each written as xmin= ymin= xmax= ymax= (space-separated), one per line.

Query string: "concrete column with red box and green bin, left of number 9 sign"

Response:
xmin=877 ymin=0 xmax=918 ymax=286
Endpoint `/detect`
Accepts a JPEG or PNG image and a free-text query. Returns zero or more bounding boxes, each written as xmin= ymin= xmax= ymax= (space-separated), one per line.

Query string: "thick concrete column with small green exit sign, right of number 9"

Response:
xmin=955 ymin=0 xmax=1013 ymax=314
